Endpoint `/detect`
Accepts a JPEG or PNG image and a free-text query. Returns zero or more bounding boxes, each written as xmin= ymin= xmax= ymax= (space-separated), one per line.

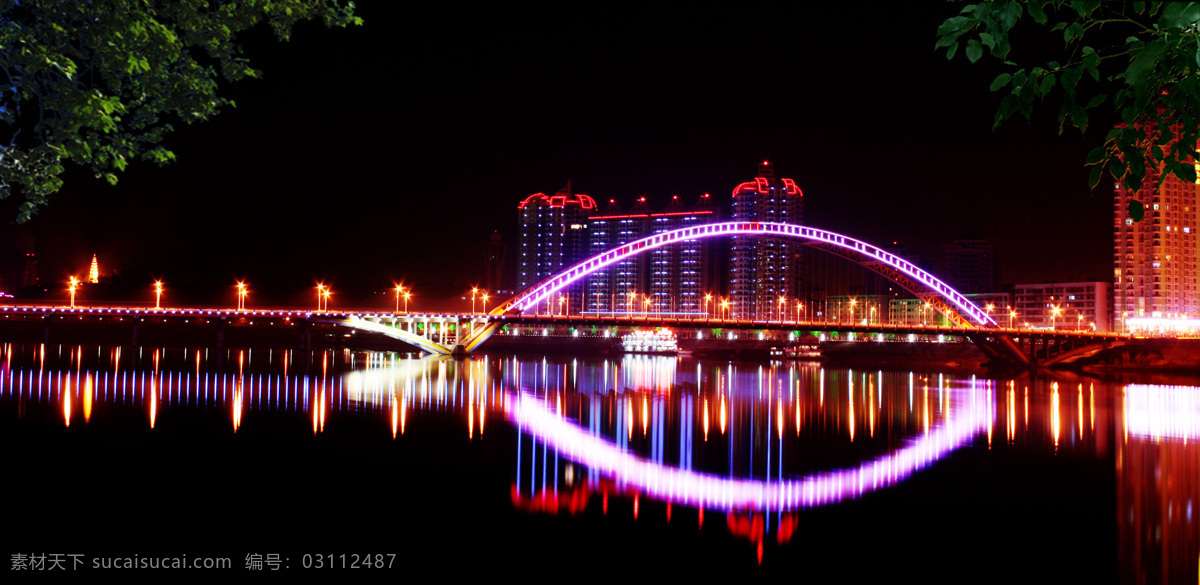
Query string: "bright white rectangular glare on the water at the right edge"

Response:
xmin=1124 ymin=384 xmax=1200 ymax=439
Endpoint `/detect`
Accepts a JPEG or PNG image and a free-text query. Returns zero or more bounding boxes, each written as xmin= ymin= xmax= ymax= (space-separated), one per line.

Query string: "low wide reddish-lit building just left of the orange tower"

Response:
xmin=1017 ymin=282 xmax=1112 ymax=332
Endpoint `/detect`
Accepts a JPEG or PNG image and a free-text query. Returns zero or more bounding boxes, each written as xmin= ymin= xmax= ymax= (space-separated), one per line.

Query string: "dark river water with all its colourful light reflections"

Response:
xmin=0 ymin=344 xmax=1200 ymax=583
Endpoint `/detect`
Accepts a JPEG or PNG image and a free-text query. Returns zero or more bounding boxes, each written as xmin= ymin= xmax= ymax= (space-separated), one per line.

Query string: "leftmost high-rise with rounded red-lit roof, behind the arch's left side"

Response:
xmin=517 ymin=181 xmax=596 ymax=313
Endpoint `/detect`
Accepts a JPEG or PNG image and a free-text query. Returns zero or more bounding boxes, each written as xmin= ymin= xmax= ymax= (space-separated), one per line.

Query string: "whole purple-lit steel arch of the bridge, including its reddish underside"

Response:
xmin=492 ymin=222 xmax=997 ymax=328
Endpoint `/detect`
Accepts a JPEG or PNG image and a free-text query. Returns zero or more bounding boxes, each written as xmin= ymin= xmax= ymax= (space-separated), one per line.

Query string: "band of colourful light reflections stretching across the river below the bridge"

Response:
xmin=0 ymin=344 xmax=1200 ymax=581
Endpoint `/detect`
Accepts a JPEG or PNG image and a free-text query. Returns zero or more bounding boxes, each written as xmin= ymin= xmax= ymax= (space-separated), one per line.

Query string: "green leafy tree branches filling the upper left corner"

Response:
xmin=0 ymin=0 xmax=361 ymax=222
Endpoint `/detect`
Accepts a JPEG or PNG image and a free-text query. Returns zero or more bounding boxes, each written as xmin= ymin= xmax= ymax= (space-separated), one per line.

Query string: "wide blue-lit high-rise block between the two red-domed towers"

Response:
xmin=584 ymin=193 xmax=719 ymax=314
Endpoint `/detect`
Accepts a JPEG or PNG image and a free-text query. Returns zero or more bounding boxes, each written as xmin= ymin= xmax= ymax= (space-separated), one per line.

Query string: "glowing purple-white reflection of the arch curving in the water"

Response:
xmin=506 ymin=387 xmax=995 ymax=509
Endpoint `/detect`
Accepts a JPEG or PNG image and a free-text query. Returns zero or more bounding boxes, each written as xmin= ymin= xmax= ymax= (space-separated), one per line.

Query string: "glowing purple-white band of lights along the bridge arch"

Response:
xmin=491 ymin=222 xmax=996 ymax=326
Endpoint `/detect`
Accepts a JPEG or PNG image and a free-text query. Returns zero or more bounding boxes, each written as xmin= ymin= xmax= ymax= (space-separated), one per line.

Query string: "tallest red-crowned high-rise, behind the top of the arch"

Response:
xmin=730 ymin=161 xmax=804 ymax=320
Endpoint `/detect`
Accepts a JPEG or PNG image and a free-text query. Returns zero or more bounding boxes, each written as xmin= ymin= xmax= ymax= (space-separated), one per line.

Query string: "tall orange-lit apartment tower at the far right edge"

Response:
xmin=1112 ymin=121 xmax=1200 ymax=332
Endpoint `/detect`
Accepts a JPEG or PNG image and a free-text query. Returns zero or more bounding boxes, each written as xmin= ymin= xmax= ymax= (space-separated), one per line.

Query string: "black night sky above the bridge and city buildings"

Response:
xmin=0 ymin=2 xmax=1112 ymax=304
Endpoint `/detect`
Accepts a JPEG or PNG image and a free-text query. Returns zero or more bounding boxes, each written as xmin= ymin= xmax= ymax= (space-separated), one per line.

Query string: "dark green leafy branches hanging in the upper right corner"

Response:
xmin=935 ymin=0 xmax=1200 ymax=198
